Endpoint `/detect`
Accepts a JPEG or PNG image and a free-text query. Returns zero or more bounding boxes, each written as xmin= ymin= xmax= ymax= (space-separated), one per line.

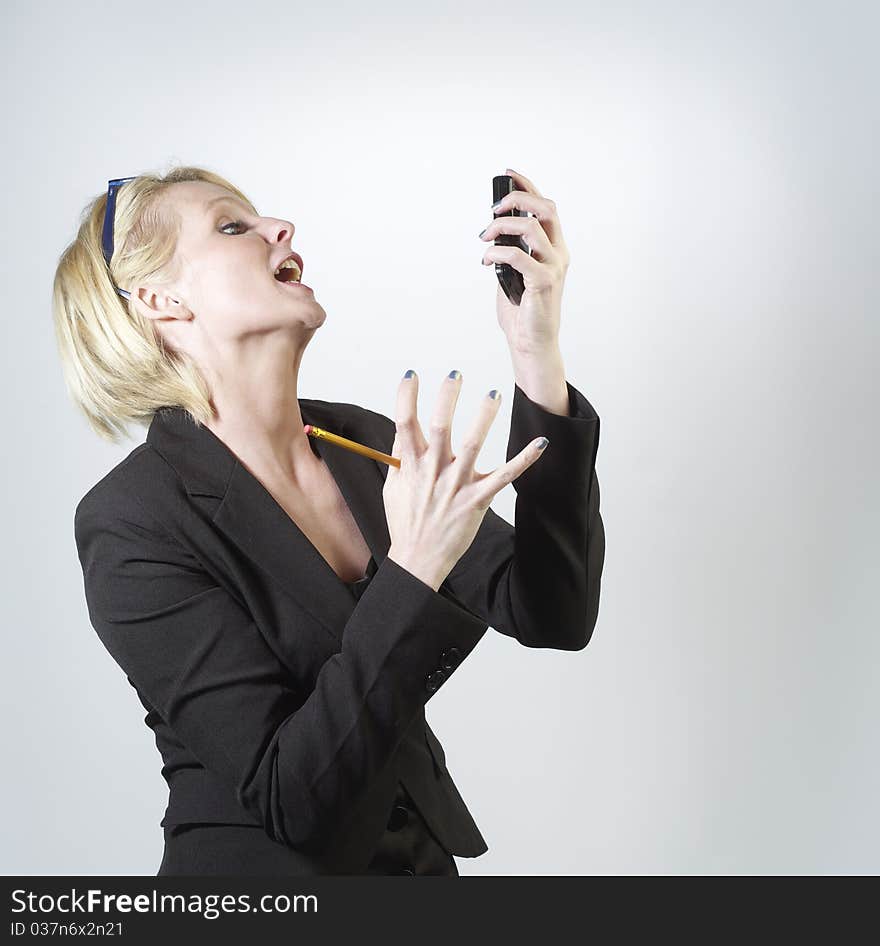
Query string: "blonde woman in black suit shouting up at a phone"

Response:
xmin=53 ymin=167 xmax=605 ymax=875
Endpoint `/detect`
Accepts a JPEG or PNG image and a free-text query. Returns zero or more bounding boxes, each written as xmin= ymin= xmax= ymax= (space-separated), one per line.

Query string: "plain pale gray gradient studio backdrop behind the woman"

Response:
xmin=0 ymin=0 xmax=880 ymax=875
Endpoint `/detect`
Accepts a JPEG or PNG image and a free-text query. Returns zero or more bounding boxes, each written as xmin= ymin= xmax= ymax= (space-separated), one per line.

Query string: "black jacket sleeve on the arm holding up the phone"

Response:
xmin=360 ymin=382 xmax=605 ymax=650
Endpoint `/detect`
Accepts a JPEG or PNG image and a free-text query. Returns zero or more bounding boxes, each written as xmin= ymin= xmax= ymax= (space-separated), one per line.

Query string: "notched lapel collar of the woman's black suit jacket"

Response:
xmin=147 ymin=398 xmax=391 ymax=640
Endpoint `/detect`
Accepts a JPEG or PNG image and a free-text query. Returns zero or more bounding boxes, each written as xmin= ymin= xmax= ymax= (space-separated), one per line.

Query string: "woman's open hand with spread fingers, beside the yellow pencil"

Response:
xmin=382 ymin=371 xmax=546 ymax=591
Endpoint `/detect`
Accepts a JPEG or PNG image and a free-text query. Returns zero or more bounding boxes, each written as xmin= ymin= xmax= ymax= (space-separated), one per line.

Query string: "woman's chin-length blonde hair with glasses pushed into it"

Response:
xmin=52 ymin=166 xmax=256 ymax=443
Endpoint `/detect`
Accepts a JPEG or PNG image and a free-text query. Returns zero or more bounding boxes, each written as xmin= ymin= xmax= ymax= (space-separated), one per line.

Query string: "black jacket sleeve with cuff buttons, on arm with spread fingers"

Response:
xmin=74 ymin=480 xmax=486 ymax=852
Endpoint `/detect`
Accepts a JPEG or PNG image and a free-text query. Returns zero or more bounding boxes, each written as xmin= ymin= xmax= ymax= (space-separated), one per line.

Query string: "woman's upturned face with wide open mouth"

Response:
xmin=143 ymin=181 xmax=326 ymax=356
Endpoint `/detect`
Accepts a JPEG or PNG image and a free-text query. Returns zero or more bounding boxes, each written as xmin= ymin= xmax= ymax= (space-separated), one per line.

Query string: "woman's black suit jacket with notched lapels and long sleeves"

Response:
xmin=75 ymin=376 xmax=605 ymax=873
